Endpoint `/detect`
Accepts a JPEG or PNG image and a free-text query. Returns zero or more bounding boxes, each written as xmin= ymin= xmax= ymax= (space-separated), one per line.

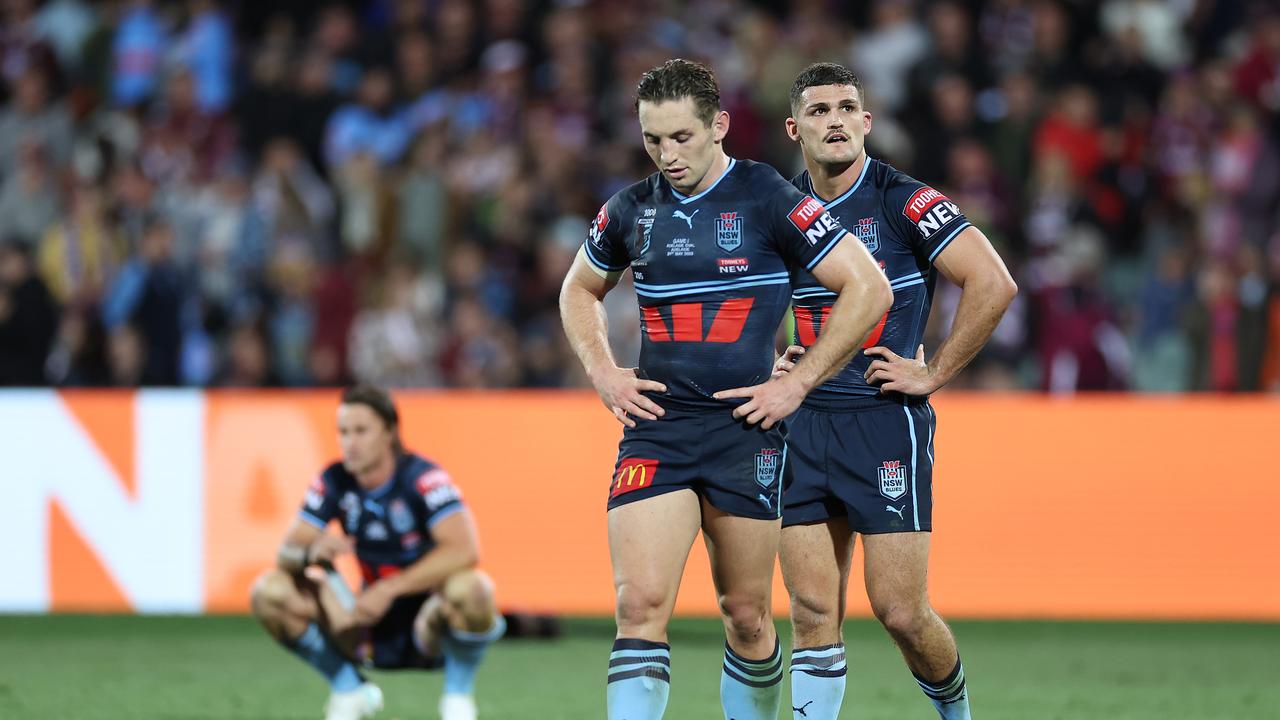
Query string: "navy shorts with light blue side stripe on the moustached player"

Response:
xmin=782 ymin=400 xmax=936 ymax=534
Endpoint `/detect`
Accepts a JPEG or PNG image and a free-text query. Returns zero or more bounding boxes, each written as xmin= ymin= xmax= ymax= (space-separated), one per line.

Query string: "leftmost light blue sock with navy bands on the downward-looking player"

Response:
xmin=605 ymin=638 xmax=671 ymax=720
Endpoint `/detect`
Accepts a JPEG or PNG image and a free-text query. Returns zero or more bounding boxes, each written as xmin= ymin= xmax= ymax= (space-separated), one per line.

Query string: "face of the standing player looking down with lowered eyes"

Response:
xmin=640 ymin=97 xmax=728 ymax=195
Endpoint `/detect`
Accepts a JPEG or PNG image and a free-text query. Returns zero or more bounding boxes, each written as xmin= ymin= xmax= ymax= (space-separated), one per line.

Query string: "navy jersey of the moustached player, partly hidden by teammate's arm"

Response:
xmin=791 ymin=156 xmax=970 ymax=407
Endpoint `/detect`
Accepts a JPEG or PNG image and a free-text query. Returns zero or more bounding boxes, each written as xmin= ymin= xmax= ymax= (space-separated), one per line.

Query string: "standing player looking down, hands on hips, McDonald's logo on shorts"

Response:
xmin=561 ymin=60 xmax=891 ymax=720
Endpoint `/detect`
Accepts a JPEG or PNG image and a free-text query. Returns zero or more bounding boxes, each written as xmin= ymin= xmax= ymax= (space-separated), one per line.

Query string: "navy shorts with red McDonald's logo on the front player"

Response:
xmin=609 ymin=407 xmax=791 ymax=520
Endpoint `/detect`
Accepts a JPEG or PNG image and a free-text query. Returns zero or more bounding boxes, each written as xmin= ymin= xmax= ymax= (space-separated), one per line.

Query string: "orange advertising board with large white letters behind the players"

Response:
xmin=0 ymin=391 xmax=1280 ymax=620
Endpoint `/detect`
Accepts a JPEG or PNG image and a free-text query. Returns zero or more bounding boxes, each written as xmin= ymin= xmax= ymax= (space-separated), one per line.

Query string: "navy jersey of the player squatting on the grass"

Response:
xmin=301 ymin=452 xmax=463 ymax=583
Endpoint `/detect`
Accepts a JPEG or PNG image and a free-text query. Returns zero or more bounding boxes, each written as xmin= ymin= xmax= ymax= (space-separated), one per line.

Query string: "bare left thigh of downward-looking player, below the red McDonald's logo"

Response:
xmin=608 ymin=488 xmax=701 ymax=612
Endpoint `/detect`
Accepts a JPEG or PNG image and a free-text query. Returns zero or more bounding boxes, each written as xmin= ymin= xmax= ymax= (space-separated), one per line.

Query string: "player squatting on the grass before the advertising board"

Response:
xmin=252 ymin=386 xmax=506 ymax=720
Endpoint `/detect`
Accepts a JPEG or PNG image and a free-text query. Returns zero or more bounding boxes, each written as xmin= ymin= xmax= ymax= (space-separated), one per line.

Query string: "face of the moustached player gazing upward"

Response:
xmin=787 ymin=85 xmax=872 ymax=165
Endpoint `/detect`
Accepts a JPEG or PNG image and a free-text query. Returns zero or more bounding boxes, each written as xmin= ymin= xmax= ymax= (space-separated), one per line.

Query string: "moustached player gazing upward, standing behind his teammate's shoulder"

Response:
xmin=777 ymin=63 xmax=1018 ymax=720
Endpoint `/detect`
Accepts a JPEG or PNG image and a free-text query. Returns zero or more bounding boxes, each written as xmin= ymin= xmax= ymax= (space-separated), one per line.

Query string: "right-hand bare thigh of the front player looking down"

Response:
xmin=703 ymin=489 xmax=781 ymax=606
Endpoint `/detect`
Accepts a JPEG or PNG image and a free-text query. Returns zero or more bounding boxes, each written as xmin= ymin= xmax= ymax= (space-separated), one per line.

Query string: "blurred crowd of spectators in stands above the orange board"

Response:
xmin=0 ymin=0 xmax=1280 ymax=392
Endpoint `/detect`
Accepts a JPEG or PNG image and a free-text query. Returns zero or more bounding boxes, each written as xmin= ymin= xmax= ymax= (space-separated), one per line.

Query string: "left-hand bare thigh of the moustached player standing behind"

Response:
xmin=778 ymin=518 xmax=855 ymax=623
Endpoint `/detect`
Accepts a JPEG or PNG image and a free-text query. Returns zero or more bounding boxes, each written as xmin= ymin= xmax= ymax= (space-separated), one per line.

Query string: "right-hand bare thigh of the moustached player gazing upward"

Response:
xmin=863 ymin=532 xmax=932 ymax=616
